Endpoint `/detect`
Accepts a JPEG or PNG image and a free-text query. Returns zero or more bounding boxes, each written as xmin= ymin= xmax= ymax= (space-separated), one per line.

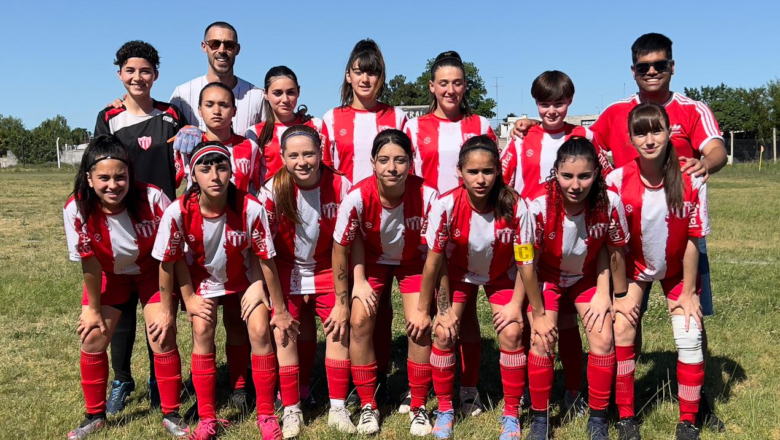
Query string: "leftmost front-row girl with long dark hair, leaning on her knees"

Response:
xmin=64 ymin=135 xmax=189 ymax=440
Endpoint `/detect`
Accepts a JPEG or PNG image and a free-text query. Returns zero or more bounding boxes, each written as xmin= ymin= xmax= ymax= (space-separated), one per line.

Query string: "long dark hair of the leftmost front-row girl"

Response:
xmin=73 ymin=134 xmax=140 ymax=223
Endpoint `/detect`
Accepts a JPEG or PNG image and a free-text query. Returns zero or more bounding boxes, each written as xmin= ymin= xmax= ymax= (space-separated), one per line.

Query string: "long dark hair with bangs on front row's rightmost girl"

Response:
xmin=628 ymin=102 xmax=684 ymax=209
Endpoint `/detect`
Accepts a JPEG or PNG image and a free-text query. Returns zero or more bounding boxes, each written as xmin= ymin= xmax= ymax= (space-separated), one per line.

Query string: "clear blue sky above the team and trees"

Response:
xmin=0 ymin=0 xmax=780 ymax=131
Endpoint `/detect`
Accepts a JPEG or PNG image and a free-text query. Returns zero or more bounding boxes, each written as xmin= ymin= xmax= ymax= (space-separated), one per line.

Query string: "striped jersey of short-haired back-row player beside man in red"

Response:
xmin=501 ymin=124 xmax=612 ymax=199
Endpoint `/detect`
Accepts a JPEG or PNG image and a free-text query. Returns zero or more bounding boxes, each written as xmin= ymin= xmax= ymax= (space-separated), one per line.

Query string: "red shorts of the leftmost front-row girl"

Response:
xmin=81 ymin=268 xmax=160 ymax=306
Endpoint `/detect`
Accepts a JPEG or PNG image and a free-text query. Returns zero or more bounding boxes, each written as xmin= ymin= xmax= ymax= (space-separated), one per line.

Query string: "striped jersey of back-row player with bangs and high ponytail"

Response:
xmin=322 ymin=102 xmax=406 ymax=183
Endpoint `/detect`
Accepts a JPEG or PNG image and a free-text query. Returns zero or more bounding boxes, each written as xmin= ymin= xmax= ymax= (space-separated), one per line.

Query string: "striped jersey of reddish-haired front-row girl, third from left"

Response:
xmin=258 ymin=166 xmax=350 ymax=295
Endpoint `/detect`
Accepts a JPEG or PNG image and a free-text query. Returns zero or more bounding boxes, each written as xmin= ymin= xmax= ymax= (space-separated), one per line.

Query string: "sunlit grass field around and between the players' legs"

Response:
xmin=0 ymin=164 xmax=780 ymax=440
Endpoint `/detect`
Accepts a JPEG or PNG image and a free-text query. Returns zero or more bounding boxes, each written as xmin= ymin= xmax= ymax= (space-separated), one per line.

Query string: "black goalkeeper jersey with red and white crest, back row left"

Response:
xmin=95 ymin=101 xmax=187 ymax=200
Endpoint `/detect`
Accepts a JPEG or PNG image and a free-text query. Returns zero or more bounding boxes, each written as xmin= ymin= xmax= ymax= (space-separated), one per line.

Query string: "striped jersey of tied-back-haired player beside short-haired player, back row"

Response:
xmin=405 ymin=113 xmax=496 ymax=193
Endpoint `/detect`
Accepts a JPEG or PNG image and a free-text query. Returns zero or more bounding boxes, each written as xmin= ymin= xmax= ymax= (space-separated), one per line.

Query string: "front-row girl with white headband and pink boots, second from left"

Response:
xmin=153 ymin=141 xmax=297 ymax=440
